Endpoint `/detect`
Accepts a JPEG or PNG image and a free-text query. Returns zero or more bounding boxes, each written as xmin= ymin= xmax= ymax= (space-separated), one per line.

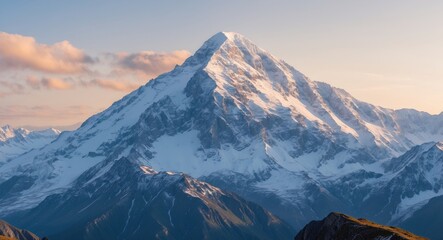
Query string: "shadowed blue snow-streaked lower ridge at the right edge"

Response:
xmin=325 ymin=142 xmax=443 ymax=239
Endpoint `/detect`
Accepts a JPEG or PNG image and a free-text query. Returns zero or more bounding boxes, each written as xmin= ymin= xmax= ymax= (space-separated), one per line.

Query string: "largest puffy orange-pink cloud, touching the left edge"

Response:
xmin=0 ymin=32 xmax=93 ymax=73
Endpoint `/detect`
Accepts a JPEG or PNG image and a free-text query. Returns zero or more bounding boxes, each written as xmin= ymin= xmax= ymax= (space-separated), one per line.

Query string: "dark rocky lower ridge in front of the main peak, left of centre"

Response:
xmin=7 ymin=158 xmax=294 ymax=240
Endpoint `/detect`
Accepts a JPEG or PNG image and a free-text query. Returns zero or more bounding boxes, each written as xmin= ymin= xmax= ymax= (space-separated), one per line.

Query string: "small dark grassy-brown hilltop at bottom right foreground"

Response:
xmin=295 ymin=213 xmax=426 ymax=240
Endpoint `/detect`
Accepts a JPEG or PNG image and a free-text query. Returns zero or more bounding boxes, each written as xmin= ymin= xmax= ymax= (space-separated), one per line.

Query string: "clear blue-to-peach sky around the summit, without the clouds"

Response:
xmin=0 ymin=0 xmax=443 ymax=128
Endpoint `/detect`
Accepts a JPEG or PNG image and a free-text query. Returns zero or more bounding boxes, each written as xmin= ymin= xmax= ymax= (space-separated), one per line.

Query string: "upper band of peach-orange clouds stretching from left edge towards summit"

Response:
xmin=0 ymin=32 xmax=190 ymax=97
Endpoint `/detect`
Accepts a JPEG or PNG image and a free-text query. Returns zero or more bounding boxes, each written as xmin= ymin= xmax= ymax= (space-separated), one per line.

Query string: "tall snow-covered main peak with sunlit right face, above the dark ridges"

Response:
xmin=0 ymin=33 xmax=443 ymax=231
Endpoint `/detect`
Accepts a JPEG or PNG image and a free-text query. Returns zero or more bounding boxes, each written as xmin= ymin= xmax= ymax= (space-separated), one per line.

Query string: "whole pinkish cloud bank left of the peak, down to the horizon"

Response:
xmin=0 ymin=32 xmax=190 ymax=126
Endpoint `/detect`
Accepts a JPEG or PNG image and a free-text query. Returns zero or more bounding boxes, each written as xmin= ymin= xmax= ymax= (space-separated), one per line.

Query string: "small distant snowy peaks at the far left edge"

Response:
xmin=0 ymin=125 xmax=60 ymax=165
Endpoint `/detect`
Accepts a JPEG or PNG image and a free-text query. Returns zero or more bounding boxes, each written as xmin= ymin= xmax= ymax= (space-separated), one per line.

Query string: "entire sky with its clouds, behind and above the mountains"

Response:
xmin=0 ymin=0 xmax=443 ymax=127
